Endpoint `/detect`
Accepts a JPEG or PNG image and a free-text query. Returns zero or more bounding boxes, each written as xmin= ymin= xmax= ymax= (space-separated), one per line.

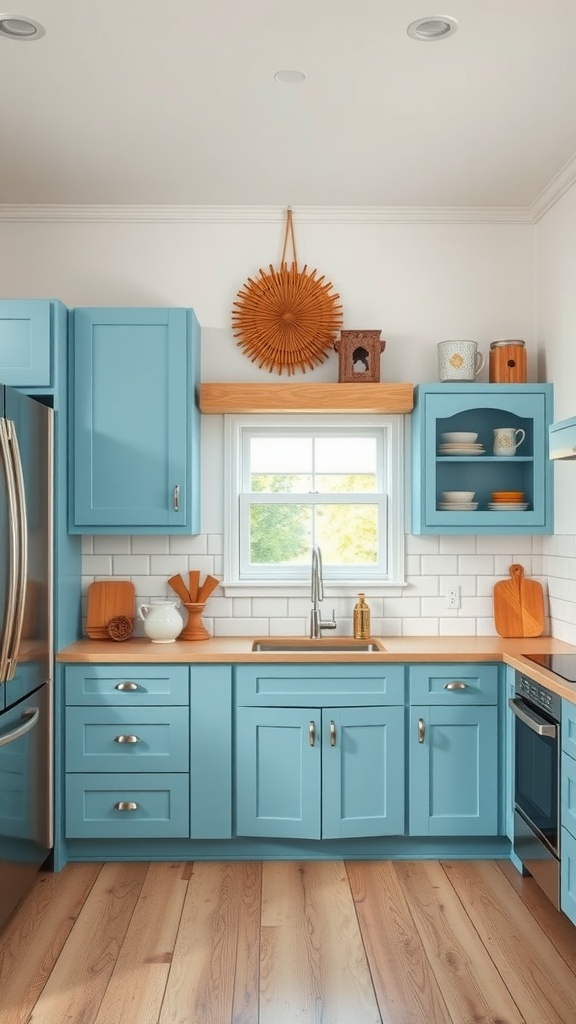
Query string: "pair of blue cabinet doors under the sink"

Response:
xmin=237 ymin=707 xmax=404 ymax=839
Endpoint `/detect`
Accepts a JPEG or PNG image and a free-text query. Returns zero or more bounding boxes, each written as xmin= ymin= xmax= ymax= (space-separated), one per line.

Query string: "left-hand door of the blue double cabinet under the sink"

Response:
xmin=236 ymin=708 xmax=321 ymax=839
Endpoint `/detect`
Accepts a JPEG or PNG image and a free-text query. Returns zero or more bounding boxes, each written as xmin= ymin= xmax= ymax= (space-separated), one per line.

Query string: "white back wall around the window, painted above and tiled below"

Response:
xmin=0 ymin=210 xmax=541 ymax=634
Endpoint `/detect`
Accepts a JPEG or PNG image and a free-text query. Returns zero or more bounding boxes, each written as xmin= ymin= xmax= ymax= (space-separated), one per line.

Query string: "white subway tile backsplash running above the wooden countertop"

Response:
xmin=82 ymin=532 xmax=576 ymax=643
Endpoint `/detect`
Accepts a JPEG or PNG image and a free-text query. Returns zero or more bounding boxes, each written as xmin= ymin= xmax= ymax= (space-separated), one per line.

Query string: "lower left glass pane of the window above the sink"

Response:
xmin=249 ymin=505 xmax=312 ymax=565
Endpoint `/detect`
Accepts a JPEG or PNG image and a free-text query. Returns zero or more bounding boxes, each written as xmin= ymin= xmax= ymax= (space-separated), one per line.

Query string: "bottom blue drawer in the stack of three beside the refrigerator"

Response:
xmin=66 ymin=772 xmax=190 ymax=839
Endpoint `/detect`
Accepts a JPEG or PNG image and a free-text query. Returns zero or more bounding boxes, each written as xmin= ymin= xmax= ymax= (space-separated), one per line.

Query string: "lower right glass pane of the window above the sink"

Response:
xmin=315 ymin=505 xmax=378 ymax=566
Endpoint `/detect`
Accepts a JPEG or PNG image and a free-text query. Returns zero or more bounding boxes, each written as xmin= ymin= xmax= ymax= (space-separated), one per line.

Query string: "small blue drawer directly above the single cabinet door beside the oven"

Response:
xmin=410 ymin=662 xmax=499 ymax=707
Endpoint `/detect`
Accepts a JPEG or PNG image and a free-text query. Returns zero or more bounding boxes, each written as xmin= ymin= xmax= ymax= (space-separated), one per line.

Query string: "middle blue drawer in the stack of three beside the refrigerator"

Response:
xmin=66 ymin=706 xmax=190 ymax=772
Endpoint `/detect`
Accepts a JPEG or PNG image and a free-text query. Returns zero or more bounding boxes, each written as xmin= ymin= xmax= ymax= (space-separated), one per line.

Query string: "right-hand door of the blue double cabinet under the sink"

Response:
xmin=322 ymin=708 xmax=405 ymax=839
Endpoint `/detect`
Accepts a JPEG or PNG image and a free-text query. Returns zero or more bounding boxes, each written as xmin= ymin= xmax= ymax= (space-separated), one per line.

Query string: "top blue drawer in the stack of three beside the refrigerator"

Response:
xmin=65 ymin=664 xmax=190 ymax=708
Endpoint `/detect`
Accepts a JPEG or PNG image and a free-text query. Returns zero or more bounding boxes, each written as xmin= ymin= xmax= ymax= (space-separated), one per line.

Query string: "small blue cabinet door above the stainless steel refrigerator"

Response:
xmin=0 ymin=299 xmax=52 ymax=389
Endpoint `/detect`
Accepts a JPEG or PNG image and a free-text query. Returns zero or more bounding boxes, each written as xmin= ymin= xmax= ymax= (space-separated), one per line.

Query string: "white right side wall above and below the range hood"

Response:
xmin=536 ymin=186 xmax=576 ymax=643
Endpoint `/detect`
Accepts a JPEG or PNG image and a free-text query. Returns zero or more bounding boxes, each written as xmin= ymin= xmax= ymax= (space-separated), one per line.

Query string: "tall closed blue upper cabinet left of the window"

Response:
xmin=70 ymin=308 xmax=200 ymax=534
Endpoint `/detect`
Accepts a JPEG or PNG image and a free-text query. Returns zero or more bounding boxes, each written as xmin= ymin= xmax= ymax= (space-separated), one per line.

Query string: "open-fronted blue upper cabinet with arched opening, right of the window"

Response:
xmin=412 ymin=384 xmax=553 ymax=534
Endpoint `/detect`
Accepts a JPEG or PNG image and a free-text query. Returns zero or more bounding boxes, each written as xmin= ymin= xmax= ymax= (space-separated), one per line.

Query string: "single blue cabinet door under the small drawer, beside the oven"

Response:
xmin=410 ymin=706 xmax=498 ymax=836
